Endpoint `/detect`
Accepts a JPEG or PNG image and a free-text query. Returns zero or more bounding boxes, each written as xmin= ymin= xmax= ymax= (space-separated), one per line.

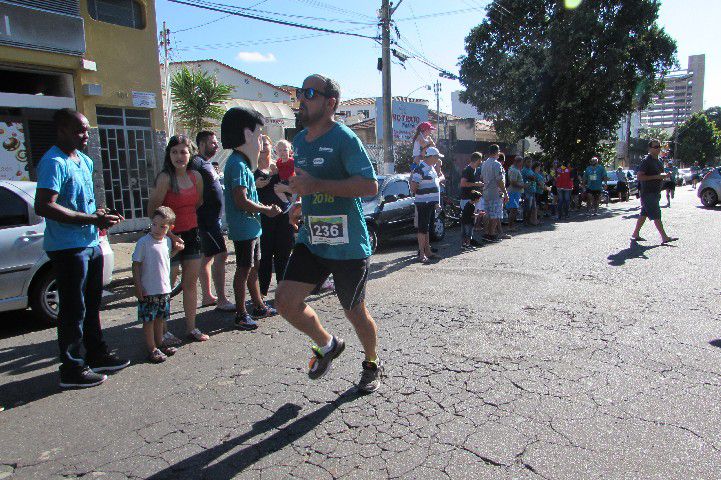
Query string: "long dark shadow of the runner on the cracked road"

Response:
xmin=149 ymin=387 xmax=362 ymax=480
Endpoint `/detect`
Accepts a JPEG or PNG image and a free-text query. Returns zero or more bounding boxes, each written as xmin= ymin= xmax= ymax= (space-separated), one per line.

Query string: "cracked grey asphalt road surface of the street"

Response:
xmin=0 ymin=187 xmax=721 ymax=479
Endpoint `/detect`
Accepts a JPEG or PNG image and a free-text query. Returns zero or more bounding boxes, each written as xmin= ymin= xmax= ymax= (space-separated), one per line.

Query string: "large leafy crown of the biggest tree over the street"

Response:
xmin=460 ymin=0 xmax=676 ymax=166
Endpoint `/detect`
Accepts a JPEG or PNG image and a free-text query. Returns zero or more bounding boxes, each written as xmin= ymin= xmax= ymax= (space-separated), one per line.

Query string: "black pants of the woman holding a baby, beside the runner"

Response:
xmin=258 ymin=213 xmax=294 ymax=296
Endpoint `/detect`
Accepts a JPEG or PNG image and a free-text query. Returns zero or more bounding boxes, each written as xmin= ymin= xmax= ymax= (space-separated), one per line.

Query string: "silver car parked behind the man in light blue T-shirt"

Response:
xmin=0 ymin=181 xmax=115 ymax=325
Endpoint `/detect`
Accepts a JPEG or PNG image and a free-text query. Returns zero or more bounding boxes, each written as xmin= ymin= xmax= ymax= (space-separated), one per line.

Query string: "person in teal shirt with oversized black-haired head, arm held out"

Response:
xmin=220 ymin=107 xmax=281 ymax=330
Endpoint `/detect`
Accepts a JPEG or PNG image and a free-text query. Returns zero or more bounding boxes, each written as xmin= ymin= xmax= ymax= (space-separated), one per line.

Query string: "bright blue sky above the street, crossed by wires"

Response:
xmin=156 ymin=0 xmax=721 ymax=112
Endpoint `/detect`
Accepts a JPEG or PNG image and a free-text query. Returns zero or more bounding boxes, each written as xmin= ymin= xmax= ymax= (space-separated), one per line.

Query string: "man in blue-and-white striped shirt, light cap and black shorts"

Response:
xmin=411 ymin=147 xmax=443 ymax=263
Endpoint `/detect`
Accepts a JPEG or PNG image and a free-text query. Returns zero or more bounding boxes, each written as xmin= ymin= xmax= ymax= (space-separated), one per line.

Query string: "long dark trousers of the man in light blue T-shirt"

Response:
xmin=47 ymin=246 xmax=107 ymax=372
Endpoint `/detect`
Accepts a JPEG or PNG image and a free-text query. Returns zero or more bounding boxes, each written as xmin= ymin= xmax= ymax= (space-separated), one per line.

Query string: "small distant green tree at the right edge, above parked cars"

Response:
xmin=673 ymin=112 xmax=721 ymax=166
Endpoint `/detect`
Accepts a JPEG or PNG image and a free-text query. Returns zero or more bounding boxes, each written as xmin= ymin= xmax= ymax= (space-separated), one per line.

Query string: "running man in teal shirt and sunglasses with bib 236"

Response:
xmin=275 ymin=74 xmax=383 ymax=393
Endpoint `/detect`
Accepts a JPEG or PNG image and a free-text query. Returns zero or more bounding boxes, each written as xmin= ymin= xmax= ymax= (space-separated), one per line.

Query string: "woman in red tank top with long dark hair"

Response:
xmin=148 ymin=135 xmax=209 ymax=342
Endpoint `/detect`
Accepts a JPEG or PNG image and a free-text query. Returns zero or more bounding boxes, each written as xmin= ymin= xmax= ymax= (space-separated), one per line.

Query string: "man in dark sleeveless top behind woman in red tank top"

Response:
xmin=189 ymin=130 xmax=235 ymax=312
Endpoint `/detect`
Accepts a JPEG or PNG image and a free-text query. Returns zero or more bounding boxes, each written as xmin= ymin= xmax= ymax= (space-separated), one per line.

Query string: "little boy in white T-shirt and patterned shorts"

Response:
xmin=133 ymin=206 xmax=183 ymax=363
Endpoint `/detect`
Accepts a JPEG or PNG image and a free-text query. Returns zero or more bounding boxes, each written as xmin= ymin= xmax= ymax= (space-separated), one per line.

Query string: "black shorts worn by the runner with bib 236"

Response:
xmin=283 ymin=243 xmax=370 ymax=310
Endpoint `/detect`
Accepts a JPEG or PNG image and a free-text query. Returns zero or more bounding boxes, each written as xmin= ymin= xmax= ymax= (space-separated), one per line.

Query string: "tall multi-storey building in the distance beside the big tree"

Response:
xmin=640 ymin=55 xmax=706 ymax=128
